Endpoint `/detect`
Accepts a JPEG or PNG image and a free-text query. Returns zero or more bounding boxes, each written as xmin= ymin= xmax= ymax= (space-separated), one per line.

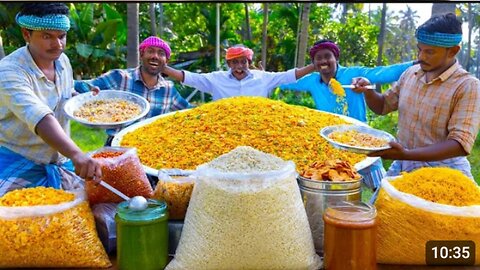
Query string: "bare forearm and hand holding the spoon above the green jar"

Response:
xmin=35 ymin=114 xmax=102 ymax=179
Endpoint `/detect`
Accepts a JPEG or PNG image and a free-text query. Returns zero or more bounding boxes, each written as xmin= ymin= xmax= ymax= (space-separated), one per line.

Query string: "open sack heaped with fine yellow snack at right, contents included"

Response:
xmin=375 ymin=168 xmax=480 ymax=264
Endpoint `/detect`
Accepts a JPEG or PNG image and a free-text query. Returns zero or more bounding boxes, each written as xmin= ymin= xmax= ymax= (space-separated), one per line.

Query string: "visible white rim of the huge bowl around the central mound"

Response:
xmin=112 ymin=109 xmax=380 ymax=177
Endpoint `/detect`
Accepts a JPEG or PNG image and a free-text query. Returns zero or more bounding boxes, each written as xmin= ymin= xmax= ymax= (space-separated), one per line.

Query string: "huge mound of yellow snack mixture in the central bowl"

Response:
xmin=121 ymin=97 xmax=365 ymax=169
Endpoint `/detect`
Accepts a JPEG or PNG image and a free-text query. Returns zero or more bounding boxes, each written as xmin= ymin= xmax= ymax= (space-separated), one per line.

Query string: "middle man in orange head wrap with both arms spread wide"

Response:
xmin=163 ymin=45 xmax=314 ymax=100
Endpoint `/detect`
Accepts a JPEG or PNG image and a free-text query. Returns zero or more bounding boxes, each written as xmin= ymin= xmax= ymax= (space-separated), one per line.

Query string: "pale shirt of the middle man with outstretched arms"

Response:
xmin=183 ymin=68 xmax=297 ymax=100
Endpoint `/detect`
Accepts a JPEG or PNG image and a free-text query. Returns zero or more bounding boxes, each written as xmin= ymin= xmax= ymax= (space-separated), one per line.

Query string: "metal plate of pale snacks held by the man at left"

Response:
xmin=63 ymin=90 xmax=150 ymax=129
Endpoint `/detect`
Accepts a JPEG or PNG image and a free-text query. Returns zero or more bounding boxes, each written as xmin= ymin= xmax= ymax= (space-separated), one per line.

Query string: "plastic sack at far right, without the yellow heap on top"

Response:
xmin=375 ymin=177 xmax=480 ymax=265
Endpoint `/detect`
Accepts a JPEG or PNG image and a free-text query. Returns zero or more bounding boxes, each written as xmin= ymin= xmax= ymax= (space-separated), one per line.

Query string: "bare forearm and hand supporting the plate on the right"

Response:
xmin=369 ymin=139 xmax=467 ymax=161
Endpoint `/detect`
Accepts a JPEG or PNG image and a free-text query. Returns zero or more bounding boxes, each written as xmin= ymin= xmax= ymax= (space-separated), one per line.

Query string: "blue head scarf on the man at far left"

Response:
xmin=15 ymin=13 xmax=70 ymax=32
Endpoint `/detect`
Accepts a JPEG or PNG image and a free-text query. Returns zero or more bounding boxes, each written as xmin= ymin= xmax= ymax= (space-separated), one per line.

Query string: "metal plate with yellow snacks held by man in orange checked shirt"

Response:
xmin=320 ymin=125 xmax=395 ymax=154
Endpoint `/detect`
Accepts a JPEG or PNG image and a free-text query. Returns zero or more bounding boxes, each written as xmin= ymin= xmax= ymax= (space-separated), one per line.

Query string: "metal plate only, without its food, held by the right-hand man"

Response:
xmin=320 ymin=125 xmax=395 ymax=154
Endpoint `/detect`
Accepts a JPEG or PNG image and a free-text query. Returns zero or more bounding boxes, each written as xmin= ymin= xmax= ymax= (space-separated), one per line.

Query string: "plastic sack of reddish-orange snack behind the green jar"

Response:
xmin=85 ymin=147 xmax=153 ymax=204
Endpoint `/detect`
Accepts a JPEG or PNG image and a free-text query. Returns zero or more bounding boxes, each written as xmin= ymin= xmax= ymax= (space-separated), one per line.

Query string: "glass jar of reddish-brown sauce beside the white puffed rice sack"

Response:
xmin=323 ymin=202 xmax=377 ymax=270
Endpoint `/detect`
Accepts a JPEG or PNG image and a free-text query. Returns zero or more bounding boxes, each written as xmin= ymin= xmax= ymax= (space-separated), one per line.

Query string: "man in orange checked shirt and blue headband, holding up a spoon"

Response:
xmin=355 ymin=13 xmax=480 ymax=181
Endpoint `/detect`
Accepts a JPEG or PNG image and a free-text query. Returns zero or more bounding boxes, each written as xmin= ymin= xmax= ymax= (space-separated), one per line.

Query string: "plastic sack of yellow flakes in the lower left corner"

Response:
xmin=0 ymin=187 xmax=111 ymax=268
